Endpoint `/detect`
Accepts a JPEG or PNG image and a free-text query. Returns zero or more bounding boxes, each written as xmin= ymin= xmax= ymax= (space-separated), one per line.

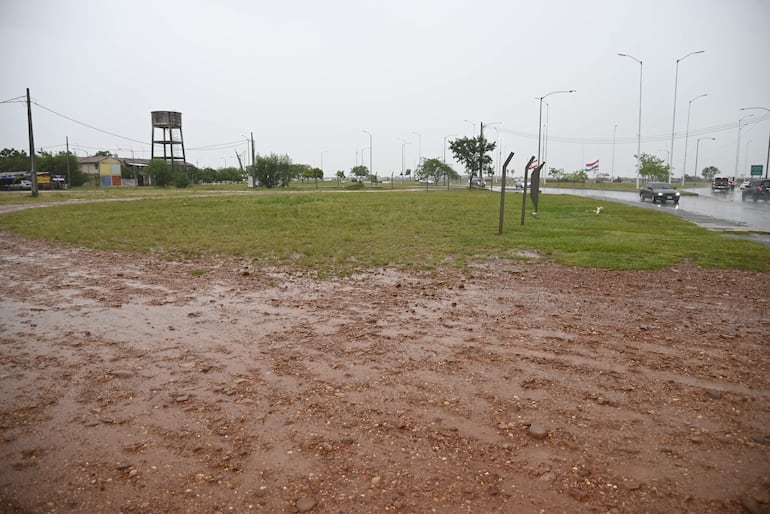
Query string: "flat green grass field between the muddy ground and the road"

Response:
xmin=0 ymin=188 xmax=770 ymax=275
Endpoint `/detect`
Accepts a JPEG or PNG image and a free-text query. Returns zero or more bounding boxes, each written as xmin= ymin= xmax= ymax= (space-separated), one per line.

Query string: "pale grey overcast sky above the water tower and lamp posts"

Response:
xmin=0 ymin=0 xmax=770 ymax=177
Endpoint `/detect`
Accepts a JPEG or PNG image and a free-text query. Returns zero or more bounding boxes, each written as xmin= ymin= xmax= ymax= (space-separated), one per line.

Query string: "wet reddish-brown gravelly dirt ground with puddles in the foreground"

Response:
xmin=0 ymin=233 xmax=770 ymax=513
